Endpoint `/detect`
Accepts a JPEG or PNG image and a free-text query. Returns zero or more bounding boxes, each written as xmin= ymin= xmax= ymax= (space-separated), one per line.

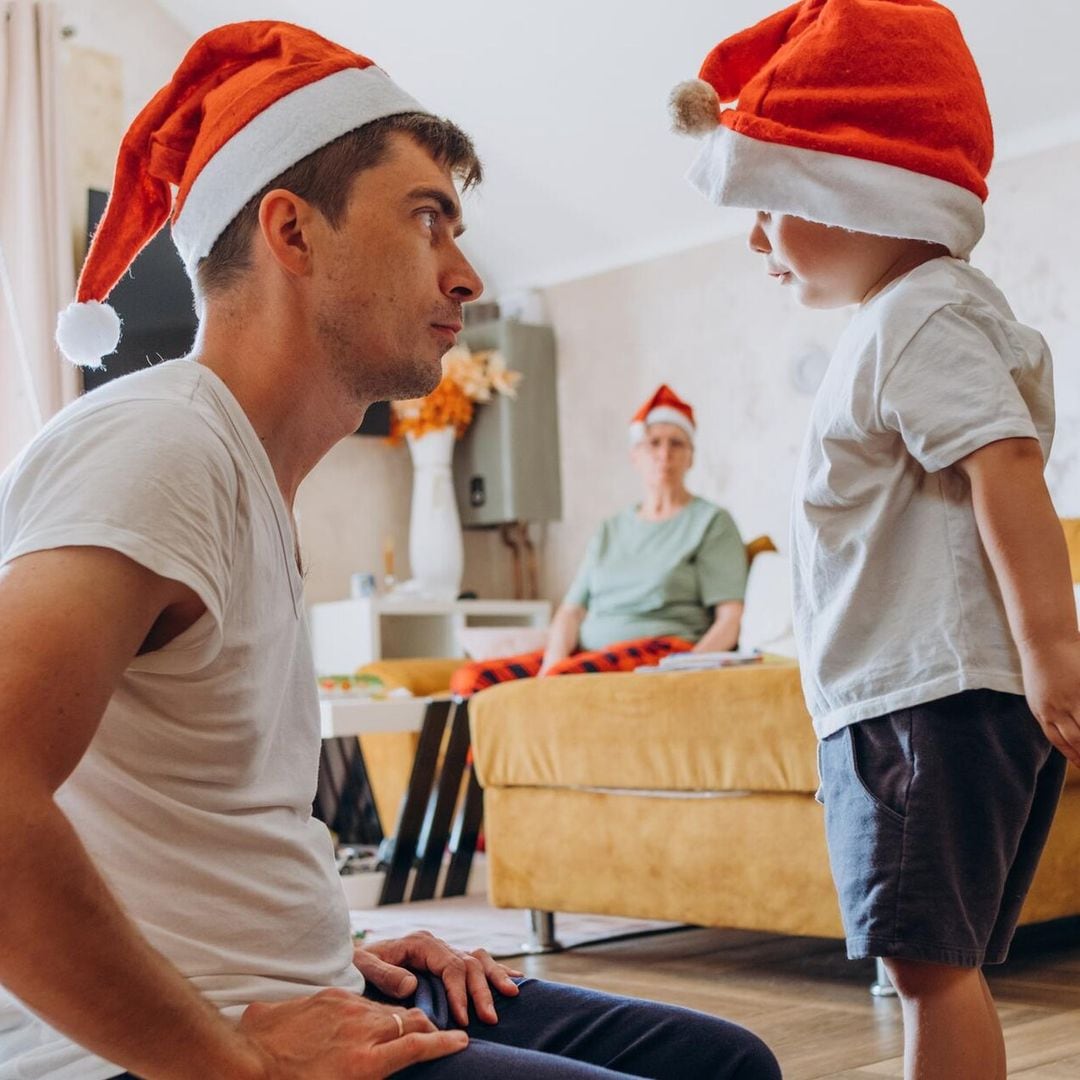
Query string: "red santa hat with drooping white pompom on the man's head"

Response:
xmin=56 ymin=22 xmax=428 ymax=367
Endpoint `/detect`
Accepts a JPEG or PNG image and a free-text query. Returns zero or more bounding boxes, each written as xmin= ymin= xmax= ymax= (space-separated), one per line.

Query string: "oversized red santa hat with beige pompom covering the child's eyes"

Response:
xmin=672 ymin=0 xmax=994 ymax=258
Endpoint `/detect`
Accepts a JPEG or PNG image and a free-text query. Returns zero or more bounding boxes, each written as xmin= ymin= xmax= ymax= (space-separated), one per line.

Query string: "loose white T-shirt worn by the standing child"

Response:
xmin=792 ymin=258 xmax=1054 ymax=739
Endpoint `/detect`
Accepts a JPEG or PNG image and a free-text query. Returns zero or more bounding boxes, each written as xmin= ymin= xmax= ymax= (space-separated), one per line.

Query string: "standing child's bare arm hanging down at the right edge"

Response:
xmin=956 ymin=438 xmax=1080 ymax=766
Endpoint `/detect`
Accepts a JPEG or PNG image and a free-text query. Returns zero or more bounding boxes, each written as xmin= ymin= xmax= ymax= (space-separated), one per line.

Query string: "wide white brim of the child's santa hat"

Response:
xmin=687 ymin=126 xmax=985 ymax=259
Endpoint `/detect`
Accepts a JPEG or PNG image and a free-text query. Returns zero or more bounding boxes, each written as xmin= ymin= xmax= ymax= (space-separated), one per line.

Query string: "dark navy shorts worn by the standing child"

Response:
xmin=819 ymin=690 xmax=1066 ymax=968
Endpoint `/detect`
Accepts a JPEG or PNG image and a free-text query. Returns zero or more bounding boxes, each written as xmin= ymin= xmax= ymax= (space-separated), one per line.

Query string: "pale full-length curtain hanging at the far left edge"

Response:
xmin=0 ymin=0 xmax=80 ymax=470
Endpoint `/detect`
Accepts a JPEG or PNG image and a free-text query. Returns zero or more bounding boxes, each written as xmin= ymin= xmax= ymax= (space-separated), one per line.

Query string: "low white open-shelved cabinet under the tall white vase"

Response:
xmin=310 ymin=595 xmax=551 ymax=675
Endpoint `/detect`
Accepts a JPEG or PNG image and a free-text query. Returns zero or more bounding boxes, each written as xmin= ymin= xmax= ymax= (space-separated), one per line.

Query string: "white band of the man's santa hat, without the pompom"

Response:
xmin=173 ymin=66 xmax=429 ymax=279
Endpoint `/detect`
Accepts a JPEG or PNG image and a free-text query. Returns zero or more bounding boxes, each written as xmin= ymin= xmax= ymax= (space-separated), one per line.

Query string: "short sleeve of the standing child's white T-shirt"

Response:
xmin=878 ymin=307 xmax=1039 ymax=472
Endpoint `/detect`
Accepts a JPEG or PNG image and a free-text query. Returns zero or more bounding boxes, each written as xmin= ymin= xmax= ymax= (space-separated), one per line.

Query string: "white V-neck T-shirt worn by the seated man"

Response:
xmin=0 ymin=360 xmax=364 ymax=1080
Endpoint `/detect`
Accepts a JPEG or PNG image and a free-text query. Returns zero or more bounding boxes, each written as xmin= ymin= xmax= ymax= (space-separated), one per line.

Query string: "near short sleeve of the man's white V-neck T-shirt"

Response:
xmin=0 ymin=400 xmax=239 ymax=671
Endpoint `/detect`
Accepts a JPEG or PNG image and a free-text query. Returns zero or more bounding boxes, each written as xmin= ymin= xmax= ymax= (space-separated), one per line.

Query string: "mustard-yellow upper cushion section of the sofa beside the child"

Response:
xmin=469 ymin=661 xmax=818 ymax=794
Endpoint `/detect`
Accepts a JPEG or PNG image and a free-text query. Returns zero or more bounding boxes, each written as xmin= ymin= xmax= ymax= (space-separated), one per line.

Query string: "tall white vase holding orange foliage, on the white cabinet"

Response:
xmin=406 ymin=428 xmax=465 ymax=600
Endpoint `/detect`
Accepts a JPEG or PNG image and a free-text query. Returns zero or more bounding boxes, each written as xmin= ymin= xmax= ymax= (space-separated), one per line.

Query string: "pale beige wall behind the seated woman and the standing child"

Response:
xmin=544 ymin=137 xmax=1080 ymax=597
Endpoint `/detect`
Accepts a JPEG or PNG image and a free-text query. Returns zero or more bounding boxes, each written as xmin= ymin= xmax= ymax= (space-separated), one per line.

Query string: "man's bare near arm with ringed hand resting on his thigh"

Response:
xmin=0 ymin=548 xmax=463 ymax=1080
